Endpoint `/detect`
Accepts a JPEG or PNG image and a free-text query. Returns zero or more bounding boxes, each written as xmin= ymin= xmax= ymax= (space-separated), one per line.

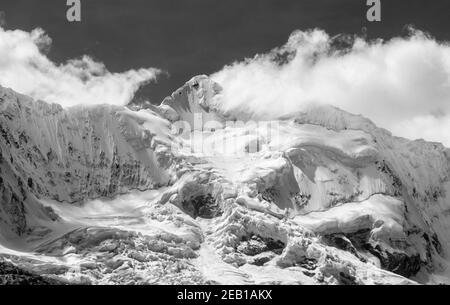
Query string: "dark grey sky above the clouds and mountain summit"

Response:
xmin=0 ymin=0 xmax=450 ymax=103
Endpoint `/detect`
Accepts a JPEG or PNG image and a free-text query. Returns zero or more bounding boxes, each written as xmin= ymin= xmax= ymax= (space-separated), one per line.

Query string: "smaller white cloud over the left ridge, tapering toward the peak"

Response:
xmin=0 ymin=27 xmax=160 ymax=106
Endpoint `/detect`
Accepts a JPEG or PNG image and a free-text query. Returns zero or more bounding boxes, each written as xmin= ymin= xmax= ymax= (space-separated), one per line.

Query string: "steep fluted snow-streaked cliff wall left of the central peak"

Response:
xmin=0 ymin=88 xmax=175 ymax=233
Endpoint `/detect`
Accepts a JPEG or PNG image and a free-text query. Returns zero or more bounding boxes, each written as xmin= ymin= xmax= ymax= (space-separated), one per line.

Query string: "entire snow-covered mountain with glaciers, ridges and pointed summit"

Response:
xmin=0 ymin=76 xmax=450 ymax=284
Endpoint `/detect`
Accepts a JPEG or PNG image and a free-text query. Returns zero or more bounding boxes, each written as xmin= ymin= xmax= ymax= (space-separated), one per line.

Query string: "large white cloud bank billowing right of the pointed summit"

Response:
xmin=211 ymin=29 xmax=450 ymax=146
